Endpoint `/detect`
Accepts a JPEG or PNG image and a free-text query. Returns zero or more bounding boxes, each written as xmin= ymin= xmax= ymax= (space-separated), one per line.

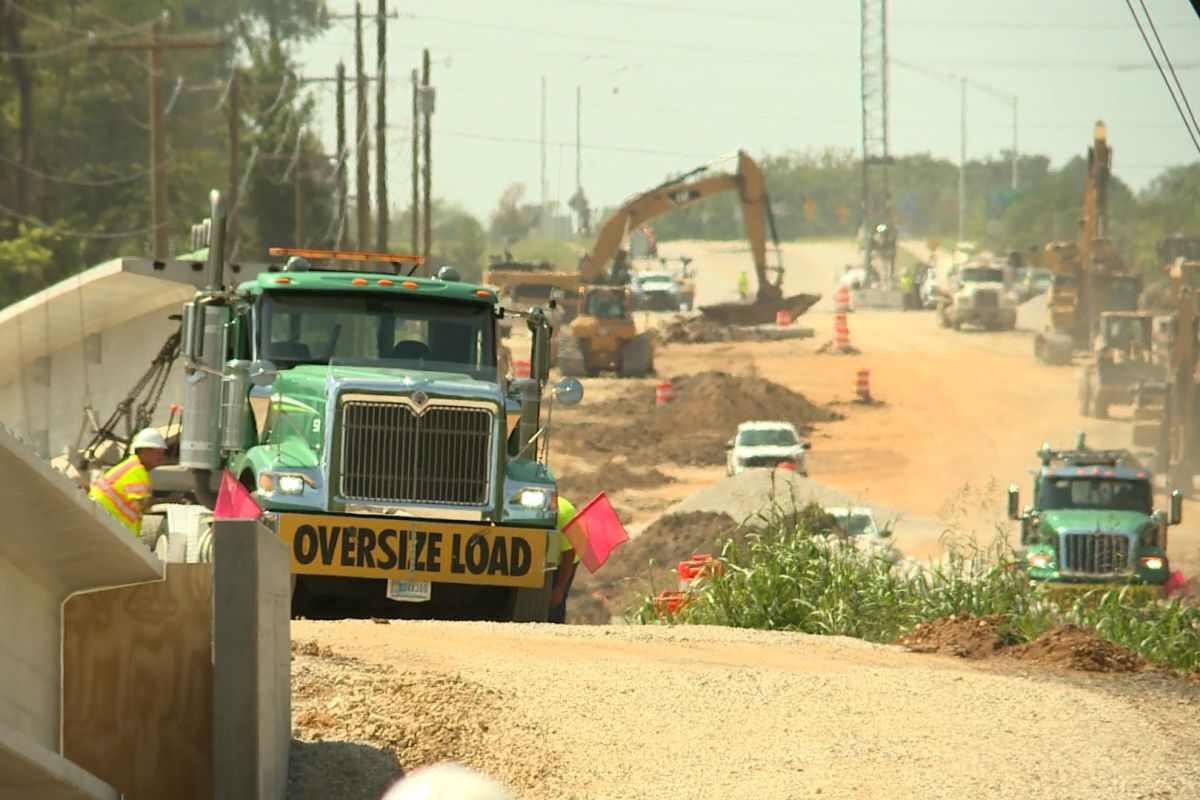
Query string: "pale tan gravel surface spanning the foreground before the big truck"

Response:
xmin=292 ymin=621 xmax=1200 ymax=800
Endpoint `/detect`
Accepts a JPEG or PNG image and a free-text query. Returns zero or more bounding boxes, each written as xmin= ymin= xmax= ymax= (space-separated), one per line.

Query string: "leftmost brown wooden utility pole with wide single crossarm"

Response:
xmin=91 ymin=14 xmax=226 ymax=260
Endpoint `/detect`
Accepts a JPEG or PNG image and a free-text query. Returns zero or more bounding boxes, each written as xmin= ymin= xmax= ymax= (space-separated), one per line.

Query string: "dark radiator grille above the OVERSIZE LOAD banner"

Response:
xmin=341 ymin=401 xmax=492 ymax=506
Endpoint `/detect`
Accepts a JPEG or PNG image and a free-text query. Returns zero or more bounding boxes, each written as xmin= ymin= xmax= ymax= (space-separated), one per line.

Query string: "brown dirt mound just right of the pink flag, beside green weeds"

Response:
xmin=566 ymin=511 xmax=745 ymax=625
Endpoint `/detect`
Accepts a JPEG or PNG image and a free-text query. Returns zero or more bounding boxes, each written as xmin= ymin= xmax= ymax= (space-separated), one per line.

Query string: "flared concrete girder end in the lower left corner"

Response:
xmin=0 ymin=428 xmax=163 ymax=800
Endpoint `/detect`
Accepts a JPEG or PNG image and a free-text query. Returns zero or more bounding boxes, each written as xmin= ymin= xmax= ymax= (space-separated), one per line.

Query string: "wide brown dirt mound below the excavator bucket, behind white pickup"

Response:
xmin=559 ymin=372 xmax=840 ymax=467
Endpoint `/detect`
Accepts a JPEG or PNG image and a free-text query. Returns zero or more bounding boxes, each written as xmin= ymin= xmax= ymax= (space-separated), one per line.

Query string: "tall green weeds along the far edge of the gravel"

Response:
xmin=632 ymin=503 xmax=1200 ymax=673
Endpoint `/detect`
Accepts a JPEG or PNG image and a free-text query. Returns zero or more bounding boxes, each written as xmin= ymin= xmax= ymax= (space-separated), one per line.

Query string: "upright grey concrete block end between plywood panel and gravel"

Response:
xmin=212 ymin=519 xmax=292 ymax=800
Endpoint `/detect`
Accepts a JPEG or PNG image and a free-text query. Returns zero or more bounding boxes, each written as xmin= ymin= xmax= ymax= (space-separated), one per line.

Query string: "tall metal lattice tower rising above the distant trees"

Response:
xmin=859 ymin=0 xmax=895 ymax=282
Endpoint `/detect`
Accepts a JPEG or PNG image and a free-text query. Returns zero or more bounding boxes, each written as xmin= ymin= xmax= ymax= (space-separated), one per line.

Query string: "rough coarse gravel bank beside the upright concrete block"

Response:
xmin=288 ymin=642 xmax=552 ymax=800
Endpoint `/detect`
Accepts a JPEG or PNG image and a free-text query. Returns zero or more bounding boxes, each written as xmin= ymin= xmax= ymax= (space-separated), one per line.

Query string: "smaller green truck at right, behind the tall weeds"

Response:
xmin=1008 ymin=434 xmax=1183 ymax=589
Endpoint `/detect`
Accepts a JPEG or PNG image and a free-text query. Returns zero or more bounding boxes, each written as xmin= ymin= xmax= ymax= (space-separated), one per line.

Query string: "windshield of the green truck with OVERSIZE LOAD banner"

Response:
xmin=259 ymin=293 xmax=496 ymax=380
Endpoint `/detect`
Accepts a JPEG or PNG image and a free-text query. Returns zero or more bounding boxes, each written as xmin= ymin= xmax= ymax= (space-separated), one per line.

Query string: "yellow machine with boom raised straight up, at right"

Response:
xmin=1033 ymin=122 xmax=1141 ymax=363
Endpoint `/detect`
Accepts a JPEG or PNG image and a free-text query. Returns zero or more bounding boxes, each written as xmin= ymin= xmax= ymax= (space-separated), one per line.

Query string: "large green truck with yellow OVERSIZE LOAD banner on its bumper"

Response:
xmin=125 ymin=192 xmax=583 ymax=621
